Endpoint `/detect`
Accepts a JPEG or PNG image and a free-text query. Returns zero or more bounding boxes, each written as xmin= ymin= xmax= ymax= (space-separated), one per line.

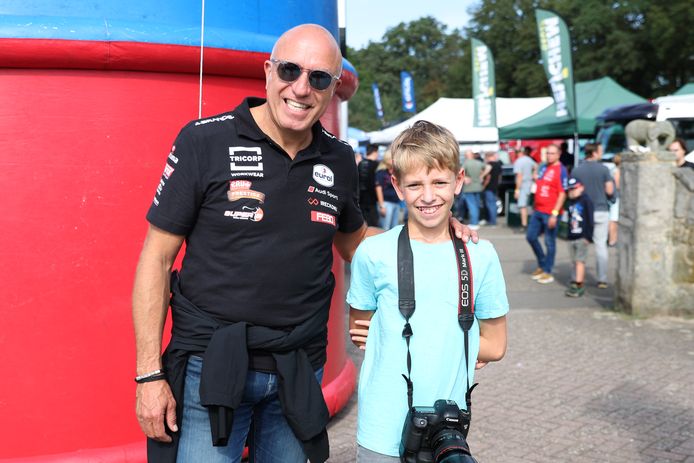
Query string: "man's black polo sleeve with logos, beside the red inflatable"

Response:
xmin=147 ymin=128 xmax=202 ymax=236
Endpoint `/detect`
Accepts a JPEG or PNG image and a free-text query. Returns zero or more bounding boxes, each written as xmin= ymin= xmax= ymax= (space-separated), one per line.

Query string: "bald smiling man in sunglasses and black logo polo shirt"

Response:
xmin=133 ymin=24 xmax=476 ymax=463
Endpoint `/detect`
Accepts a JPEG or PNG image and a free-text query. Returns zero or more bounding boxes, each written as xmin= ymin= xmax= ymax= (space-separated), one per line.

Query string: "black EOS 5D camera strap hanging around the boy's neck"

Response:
xmin=398 ymin=223 xmax=476 ymax=412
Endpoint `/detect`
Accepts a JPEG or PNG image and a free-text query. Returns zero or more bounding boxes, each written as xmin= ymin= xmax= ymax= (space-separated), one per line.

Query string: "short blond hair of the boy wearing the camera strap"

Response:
xmin=390 ymin=121 xmax=460 ymax=179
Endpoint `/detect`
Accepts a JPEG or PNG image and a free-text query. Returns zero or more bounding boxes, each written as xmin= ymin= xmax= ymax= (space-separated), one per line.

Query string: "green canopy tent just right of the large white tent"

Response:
xmin=499 ymin=77 xmax=646 ymax=140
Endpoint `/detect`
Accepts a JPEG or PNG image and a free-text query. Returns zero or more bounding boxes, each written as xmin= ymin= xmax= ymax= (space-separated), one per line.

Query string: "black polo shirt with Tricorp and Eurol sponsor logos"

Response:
xmin=147 ymin=98 xmax=363 ymax=366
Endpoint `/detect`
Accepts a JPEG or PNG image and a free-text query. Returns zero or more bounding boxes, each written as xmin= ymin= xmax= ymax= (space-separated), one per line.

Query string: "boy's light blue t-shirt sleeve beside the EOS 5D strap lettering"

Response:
xmin=472 ymin=240 xmax=508 ymax=319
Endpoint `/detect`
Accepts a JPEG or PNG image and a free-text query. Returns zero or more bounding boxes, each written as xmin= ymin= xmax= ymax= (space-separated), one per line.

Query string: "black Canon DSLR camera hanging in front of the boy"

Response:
xmin=400 ymin=399 xmax=477 ymax=463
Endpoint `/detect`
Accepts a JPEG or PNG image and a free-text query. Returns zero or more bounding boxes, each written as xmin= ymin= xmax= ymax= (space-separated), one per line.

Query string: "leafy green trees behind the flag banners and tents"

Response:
xmin=348 ymin=0 xmax=694 ymax=130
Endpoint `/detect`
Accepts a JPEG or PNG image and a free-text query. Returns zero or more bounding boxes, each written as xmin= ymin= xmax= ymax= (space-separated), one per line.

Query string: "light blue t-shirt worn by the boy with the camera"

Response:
xmin=347 ymin=226 xmax=508 ymax=456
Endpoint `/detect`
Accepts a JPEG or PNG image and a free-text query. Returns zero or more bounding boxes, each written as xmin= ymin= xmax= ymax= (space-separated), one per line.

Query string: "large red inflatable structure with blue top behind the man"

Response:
xmin=0 ymin=0 xmax=357 ymax=462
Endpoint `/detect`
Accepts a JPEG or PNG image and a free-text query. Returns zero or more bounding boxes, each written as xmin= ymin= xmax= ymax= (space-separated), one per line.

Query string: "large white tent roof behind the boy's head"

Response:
xmin=368 ymin=96 xmax=552 ymax=151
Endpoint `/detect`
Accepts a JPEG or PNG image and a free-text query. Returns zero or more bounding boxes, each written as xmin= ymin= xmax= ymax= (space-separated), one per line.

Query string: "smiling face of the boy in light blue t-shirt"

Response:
xmin=392 ymin=166 xmax=464 ymax=234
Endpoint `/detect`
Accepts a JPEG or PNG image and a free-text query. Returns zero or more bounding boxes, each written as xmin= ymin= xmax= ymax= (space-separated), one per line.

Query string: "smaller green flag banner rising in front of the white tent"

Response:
xmin=472 ymin=39 xmax=496 ymax=127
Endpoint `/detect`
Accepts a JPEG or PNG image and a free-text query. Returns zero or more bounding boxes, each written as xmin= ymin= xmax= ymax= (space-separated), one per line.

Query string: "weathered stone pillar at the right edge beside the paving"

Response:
xmin=615 ymin=151 xmax=694 ymax=317
